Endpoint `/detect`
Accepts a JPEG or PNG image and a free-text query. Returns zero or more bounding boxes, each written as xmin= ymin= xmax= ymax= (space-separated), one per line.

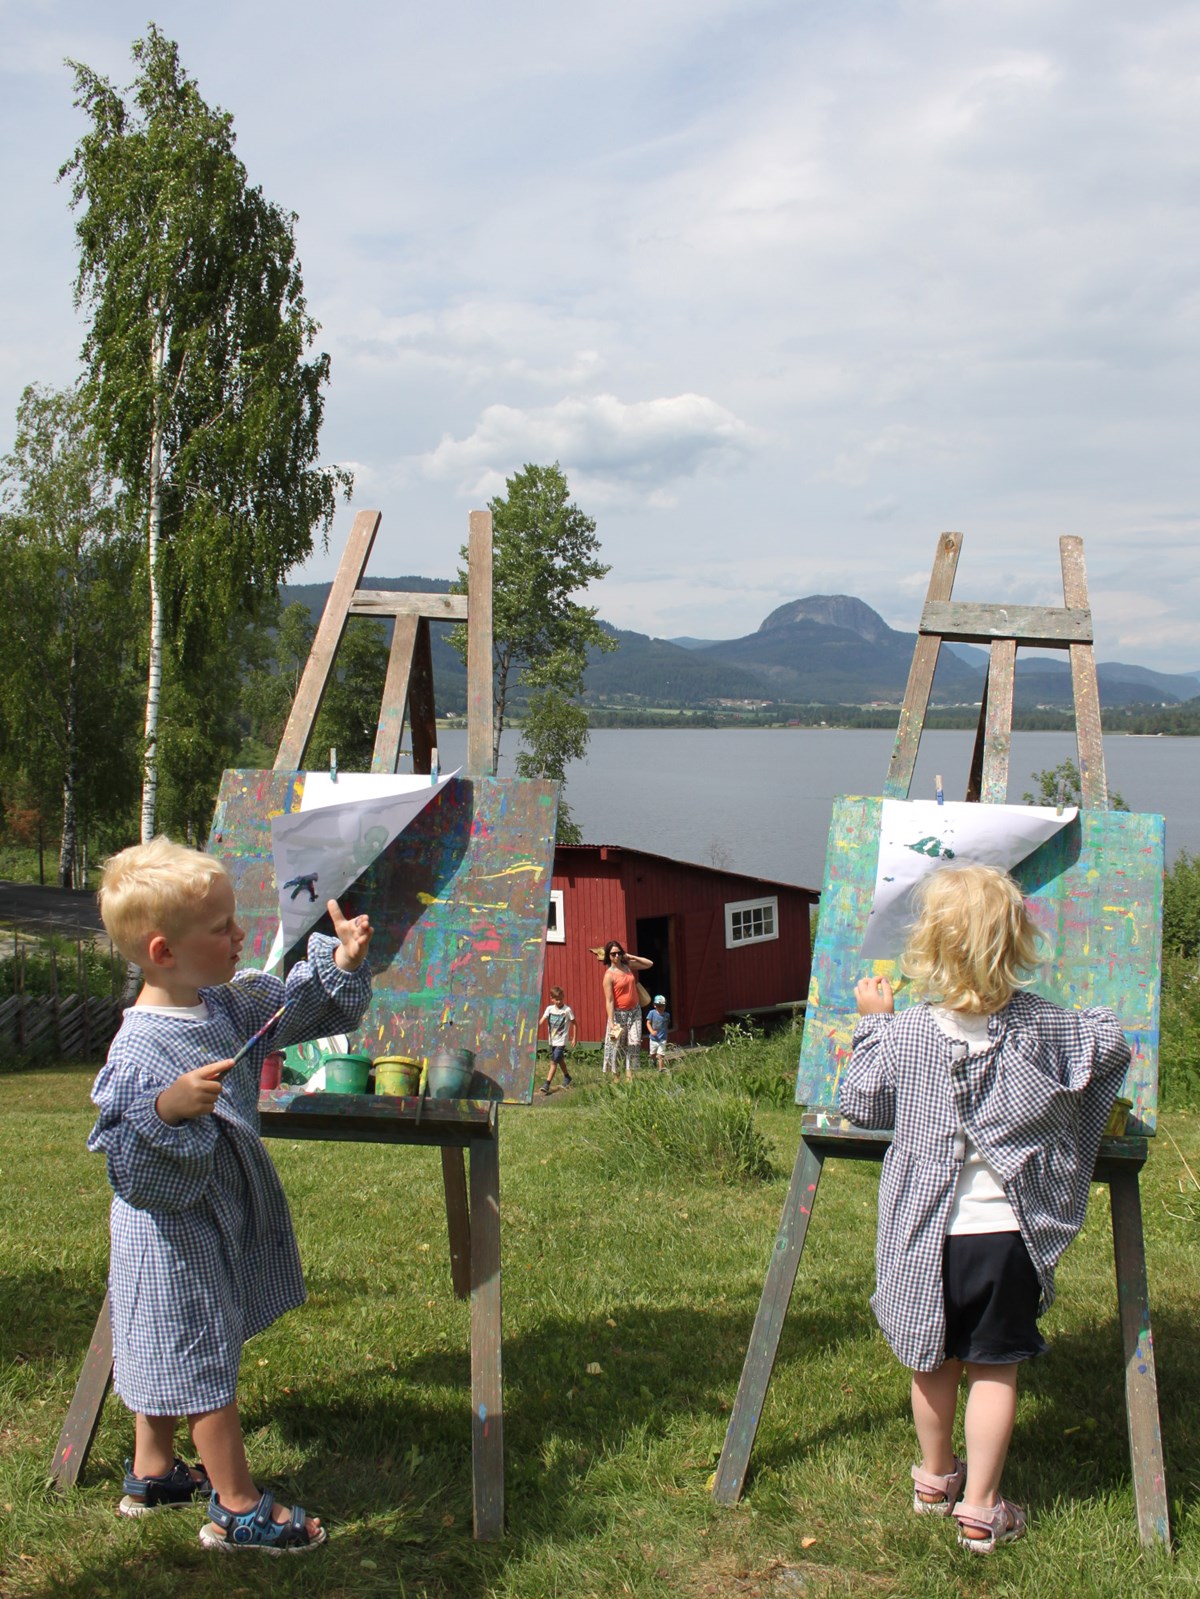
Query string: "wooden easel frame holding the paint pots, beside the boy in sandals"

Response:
xmin=51 ymin=510 xmax=518 ymax=1538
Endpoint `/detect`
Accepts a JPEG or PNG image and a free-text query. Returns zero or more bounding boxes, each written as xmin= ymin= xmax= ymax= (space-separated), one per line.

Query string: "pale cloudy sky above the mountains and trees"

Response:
xmin=0 ymin=0 xmax=1200 ymax=672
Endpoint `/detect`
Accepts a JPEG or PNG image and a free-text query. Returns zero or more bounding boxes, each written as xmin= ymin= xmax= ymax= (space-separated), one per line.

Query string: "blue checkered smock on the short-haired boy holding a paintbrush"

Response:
xmin=88 ymin=934 xmax=371 ymax=1415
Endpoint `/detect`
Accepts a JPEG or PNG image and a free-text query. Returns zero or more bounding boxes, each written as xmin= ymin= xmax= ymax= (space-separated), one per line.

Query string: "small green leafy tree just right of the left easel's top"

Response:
xmin=451 ymin=461 xmax=616 ymax=841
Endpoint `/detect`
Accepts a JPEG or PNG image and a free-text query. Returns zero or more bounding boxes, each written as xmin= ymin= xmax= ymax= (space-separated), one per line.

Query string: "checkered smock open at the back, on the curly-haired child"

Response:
xmin=838 ymin=993 xmax=1130 ymax=1372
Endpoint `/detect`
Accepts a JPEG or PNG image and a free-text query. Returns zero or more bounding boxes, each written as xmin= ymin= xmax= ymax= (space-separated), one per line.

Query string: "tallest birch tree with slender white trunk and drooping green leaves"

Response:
xmin=59 ymin=26 xmax=350 ymax=838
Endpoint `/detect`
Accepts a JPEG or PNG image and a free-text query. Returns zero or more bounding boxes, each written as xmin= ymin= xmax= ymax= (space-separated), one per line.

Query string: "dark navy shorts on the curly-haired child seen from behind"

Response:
xmin=942 ymin=1233 xmax=1046 ymax=1366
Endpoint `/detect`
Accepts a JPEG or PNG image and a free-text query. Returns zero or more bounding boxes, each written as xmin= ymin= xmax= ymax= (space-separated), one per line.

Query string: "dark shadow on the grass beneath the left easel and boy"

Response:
xmin=14 ymin=1306 xmax=861 ymax=1599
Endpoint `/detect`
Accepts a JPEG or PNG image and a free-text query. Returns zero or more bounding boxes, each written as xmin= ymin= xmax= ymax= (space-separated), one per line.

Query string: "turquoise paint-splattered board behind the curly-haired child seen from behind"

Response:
xmin=795 ymin=796 xmax=1165 ymax=1135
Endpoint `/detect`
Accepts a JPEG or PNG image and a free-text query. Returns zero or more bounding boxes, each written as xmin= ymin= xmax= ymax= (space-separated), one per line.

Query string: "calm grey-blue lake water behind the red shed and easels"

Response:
xmin=440 ymin=728 xmax=1200 ymax=889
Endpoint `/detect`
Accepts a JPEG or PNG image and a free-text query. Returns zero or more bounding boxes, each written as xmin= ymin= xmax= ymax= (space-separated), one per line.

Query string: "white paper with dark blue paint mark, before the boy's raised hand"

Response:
xmin=266 ymin=772 xmax=456 ymax=971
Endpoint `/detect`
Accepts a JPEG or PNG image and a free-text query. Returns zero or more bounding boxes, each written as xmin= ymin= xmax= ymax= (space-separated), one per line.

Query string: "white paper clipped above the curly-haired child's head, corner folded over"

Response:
xmin=859 ymin=800 xmax=1078 ymax=959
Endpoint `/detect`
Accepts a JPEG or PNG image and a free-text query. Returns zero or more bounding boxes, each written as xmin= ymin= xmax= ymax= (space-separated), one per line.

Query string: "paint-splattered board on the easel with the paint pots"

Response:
xmin=208 ymin=771 xmax=558 ymax=1105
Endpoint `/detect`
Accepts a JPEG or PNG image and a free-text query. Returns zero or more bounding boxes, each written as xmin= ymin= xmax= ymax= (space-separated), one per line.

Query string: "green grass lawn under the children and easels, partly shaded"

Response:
xmin=0 ymin=1065 xmax=1200 ymax=1599
